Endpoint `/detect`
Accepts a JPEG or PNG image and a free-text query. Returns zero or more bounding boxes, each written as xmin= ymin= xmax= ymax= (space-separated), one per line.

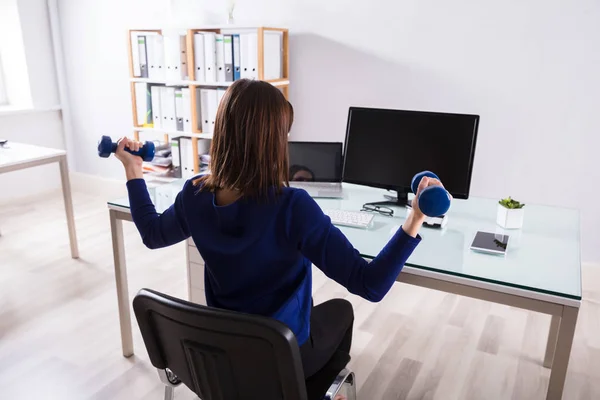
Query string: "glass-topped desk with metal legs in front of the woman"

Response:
xmin=108 ymin=181 xmax=581 ymax=399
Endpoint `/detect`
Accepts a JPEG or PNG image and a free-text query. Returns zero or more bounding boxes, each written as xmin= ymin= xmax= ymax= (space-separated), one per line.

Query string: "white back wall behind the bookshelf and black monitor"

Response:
xmin=60 ymin=0 xmax=600 ymax=261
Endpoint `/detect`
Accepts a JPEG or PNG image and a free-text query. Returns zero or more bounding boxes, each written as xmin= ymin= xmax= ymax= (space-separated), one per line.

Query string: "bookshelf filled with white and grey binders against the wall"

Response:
xmin=128 ymin=26 xmax=290 ymax=180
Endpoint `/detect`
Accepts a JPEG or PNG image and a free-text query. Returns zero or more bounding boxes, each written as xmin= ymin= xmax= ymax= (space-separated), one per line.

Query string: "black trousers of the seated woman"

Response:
xmin=300 ymin=299 xmax=354 ymax=378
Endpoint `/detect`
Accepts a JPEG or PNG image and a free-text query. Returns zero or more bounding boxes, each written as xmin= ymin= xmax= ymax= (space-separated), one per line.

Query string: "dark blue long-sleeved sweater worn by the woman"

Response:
xmin=127 ymin=179 xmax=420 ymax=345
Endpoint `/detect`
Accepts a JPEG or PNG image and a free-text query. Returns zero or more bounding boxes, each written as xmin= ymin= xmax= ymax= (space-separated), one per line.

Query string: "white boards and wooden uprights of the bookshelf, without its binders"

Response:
xmin=127 ymin=25 xmax=290 ymax=174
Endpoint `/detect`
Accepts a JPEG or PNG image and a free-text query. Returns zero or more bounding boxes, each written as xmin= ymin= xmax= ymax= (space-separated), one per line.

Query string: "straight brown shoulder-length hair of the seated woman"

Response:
xmin=194 ymin=79 xmax=294 ymax=197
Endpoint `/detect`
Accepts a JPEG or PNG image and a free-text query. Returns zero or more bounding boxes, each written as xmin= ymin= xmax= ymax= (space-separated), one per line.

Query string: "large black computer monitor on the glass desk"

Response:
xmin=343 ymin=107 xmax=479 ymax=205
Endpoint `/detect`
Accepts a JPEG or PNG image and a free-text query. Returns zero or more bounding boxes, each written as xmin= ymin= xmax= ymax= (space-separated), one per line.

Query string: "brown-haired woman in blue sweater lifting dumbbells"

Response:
xmin=116 ymin=80 xmax=441 ymax=378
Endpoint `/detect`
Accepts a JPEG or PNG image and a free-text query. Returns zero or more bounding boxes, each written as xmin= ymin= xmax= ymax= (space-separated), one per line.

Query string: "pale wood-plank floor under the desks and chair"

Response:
xmin=0 ymin=188 xmax=600 ymax=400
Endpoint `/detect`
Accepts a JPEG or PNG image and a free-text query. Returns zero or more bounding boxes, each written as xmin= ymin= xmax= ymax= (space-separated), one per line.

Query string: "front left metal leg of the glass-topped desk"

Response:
xmin=109 ymin=210 xmax=133 ymax=357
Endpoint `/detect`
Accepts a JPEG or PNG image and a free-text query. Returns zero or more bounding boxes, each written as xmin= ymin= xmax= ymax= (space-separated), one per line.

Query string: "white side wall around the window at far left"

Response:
xmin=0 ymin=0 xmax=64 ymax=202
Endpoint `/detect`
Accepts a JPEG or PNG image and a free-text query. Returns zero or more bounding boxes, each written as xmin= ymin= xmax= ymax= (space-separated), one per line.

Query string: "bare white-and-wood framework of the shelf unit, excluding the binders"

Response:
xmin=127 ymin=25 xmax=290 ymax=173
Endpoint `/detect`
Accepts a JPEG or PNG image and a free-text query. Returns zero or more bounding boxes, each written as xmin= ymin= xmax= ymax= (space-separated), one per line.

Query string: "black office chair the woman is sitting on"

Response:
xmin=133 ymin=289 xmax=356 ymax=400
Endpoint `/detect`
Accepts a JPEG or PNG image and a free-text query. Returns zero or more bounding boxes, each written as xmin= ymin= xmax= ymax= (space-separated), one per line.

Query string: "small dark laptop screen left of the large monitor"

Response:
xmin=288 ymin=142 xmax=342 ymax=182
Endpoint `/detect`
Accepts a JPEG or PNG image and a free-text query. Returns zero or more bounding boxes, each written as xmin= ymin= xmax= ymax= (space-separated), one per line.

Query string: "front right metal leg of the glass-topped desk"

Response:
xmin=546 ymin=306 xmax=579 ymax=400
